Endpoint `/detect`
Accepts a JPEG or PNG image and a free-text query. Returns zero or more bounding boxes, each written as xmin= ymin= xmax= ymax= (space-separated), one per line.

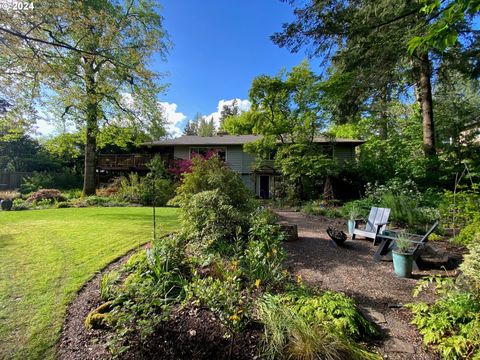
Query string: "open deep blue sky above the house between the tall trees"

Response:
xmin=153 ymin=0 xmax=318 ymax=132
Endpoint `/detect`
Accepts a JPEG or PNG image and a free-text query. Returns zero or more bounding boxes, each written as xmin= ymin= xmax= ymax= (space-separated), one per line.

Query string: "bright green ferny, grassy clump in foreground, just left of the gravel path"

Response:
xmin=258 ymin=291 xmax=380 ymax=359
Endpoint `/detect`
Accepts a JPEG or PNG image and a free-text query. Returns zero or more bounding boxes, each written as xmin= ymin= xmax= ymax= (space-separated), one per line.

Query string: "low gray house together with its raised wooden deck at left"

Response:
xmin=97 ymin=135 xmax=364 ymax=198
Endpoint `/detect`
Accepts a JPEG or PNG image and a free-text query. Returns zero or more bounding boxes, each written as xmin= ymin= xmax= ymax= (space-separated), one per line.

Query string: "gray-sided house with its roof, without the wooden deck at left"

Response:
xmin=140 ymin=135 xmax=364 ymax=198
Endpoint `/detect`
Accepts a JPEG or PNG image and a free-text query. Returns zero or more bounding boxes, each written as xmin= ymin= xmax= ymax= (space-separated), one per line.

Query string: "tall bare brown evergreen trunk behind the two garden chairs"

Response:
xmin=418 ymin=53 xmax=438 ymax=176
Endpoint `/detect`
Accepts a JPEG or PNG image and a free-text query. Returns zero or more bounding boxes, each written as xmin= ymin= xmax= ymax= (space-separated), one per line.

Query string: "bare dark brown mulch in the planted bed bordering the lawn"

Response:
xmin=57 ymin=249 xmax=262 ymax=360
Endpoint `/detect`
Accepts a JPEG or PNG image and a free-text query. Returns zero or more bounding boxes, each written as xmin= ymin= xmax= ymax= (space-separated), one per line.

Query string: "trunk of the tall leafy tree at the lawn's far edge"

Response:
xmin=83 ymin=64 xmax=98 ymax=195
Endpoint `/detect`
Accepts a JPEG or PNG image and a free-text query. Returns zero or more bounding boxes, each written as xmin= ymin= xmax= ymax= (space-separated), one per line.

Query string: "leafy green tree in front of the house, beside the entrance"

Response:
xmin=225 ymin=62 xmax=337 ymax=197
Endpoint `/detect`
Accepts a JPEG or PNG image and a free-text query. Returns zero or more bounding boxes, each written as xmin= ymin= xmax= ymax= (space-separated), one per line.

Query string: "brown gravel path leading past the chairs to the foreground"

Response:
xmin=277 ymin=211 xmax=438 ymax=359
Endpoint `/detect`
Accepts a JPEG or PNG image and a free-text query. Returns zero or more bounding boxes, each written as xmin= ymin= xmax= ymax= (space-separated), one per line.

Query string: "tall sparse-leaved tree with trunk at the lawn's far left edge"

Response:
xmin=0 ymin=0 xmax=168 ymax=195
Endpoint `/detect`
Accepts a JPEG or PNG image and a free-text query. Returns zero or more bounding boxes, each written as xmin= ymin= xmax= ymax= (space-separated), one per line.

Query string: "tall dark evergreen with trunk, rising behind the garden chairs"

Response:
xmin=272 ymin=0 xmax=478 ymax=177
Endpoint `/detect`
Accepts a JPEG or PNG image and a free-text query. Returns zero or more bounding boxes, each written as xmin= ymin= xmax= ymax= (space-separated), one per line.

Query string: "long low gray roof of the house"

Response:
xmin=140 ymin=135 xmax=365 ymax=147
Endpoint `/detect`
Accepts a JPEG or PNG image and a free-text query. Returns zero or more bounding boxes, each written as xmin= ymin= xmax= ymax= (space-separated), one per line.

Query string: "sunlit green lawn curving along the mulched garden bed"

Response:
xmin=0 ymin=208 xmax=178 ymax=359
